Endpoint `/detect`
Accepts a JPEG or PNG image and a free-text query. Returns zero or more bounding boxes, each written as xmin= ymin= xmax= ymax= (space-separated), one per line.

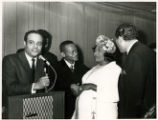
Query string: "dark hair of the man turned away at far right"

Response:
xmin=115 ymin=23 xmax=137 ymax=40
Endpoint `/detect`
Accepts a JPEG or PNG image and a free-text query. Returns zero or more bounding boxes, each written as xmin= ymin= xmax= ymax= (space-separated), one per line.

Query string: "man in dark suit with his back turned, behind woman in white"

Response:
xmin=115 ymin=24 xmax=156 ymax=118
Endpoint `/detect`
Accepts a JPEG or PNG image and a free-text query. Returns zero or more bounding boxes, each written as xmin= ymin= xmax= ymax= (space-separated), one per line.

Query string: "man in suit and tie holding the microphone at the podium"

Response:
xmin=2 ymin=30 xmax=50 ymax=96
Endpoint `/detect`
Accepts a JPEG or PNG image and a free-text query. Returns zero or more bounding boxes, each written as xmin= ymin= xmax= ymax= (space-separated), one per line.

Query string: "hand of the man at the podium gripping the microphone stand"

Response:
xmin=33 ymin=76 xmax=50 ymax=90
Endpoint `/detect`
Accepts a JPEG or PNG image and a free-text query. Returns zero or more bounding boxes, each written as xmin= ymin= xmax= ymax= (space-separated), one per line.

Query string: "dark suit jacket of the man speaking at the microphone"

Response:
xmin=2 ymin=51 xmax=44 ymax=96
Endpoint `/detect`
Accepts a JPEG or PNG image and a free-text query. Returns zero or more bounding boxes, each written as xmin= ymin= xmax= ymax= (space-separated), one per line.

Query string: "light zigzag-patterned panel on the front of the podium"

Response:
xmin=23 ymin=96 xmax=53 ymax=119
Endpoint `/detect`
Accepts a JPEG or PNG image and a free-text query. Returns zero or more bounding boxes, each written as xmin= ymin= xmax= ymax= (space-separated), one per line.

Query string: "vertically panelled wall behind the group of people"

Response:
xmin=2 ymin=2 xmax=156 ymax=67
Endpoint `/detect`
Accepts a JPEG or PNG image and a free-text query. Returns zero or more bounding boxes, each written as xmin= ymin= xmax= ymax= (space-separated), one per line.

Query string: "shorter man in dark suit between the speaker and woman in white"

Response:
xmin=55 ymin=40 xmax=88 ymax=119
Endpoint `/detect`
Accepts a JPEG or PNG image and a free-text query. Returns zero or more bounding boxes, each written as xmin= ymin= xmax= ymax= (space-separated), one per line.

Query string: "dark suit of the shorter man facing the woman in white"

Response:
xmin=55 ymin=59 xmax=88 ymax=119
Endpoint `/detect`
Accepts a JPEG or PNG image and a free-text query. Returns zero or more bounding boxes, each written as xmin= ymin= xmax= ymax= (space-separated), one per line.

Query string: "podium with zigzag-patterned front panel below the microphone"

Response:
xmin=8 ymin=91 xmax=65 ymax=119
